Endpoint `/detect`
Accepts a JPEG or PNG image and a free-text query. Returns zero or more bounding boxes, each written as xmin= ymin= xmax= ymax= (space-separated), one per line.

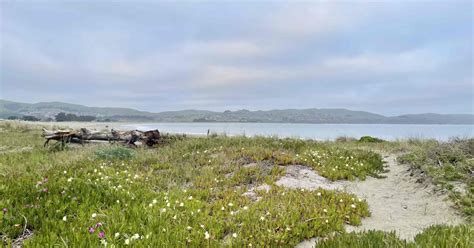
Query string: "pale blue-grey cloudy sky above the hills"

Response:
xmin=0 ymin=0 xmax=474 ymax=115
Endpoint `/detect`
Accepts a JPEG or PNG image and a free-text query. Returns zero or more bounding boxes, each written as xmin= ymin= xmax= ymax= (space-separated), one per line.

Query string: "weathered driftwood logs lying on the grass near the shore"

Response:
xmin=43 ymin=128 xmax=162 ymax=147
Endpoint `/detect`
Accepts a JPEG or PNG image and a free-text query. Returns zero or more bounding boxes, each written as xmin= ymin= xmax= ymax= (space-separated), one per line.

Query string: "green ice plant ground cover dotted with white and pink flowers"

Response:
xmin=0 ymin=122 xmax=471 ymax=247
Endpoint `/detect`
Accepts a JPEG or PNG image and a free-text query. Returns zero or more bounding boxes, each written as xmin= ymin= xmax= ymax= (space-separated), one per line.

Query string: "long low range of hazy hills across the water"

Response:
xmin=0 ymin=100 xmax=474 ymax=124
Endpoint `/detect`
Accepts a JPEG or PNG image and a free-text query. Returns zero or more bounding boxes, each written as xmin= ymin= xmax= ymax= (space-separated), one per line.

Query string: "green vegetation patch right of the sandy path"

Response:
xmin=399 ymin=139 xmax=474 ymax=221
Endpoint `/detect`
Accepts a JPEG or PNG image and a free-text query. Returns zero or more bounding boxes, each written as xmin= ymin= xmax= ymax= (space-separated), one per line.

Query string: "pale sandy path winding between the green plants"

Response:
xmin=276 ymin=155 xmax=463 ymax=247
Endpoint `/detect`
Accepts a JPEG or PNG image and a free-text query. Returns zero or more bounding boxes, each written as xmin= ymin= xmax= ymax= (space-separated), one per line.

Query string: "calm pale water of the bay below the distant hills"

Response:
xmin=121 ymin=123 xmax=474 ymax=140
